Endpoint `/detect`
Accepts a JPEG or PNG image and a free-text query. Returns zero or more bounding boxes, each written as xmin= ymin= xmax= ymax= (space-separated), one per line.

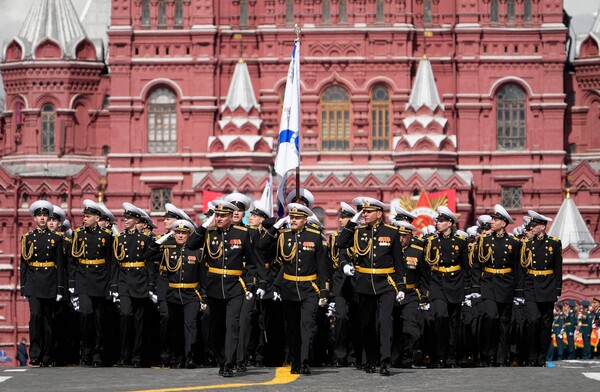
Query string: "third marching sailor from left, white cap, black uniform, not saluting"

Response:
xmin=111 ymin=203 xmax=156 ymax=367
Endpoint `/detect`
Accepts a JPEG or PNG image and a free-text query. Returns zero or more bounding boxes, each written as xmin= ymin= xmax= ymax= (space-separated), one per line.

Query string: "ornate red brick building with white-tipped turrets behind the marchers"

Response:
xmin=0 ymin=0 xmax=600 ymax=362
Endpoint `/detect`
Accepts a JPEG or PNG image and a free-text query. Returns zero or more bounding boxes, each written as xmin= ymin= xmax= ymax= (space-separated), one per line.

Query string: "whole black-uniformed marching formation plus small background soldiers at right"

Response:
xmin=21 ymin=189 xmax=599 ymax=377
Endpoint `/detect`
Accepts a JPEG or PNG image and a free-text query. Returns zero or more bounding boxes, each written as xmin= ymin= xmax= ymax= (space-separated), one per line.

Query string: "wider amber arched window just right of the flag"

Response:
xmin=321 ymin=86 xmax=350 ymax=151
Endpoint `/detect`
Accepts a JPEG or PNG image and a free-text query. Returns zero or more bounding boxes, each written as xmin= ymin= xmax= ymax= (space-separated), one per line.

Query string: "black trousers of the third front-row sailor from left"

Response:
xmin=119 ymin=295 xmax=148 ymax=362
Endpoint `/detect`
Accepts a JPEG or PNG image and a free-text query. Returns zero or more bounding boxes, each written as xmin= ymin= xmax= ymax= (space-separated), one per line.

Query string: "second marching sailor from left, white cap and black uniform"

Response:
xmin=69 ymin=200 xmax=113 ymax=367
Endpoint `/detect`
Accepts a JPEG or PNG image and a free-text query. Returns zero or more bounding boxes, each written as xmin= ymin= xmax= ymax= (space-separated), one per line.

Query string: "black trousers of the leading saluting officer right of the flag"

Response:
xmin=358 ymin=291 xmax=396 ymax=366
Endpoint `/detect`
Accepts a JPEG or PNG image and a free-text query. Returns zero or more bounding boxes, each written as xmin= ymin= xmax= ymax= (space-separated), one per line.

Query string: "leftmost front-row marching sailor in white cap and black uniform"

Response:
xmin=21 ymin=200 xmax=64 ymax=367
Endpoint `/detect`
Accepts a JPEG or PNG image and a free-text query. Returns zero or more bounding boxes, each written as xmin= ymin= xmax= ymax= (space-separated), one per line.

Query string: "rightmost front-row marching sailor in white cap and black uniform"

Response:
xmin=519 ymin=210 xmax=562 ymax=366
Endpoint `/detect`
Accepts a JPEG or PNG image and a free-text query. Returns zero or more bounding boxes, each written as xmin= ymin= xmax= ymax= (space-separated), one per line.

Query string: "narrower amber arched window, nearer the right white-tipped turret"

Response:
xmin=371 ymin=84 xmax=391 ymax=151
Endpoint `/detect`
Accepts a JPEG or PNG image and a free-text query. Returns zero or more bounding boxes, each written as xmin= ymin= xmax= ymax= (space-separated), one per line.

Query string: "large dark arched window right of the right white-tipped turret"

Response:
xmin=496 ymin=84 xmax=526 ymax=150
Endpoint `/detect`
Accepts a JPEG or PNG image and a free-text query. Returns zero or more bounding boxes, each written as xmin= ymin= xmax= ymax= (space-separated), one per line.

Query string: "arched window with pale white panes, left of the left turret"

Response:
xmin=148 ymin=87 xmax=177 ymax=153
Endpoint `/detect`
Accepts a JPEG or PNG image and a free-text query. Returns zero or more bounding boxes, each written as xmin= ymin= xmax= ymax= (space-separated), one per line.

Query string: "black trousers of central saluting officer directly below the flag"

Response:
xmin=283 ymin=295 xmax=319 ymax=368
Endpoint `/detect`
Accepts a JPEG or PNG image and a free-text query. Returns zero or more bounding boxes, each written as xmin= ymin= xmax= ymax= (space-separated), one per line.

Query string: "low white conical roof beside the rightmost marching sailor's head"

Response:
xmin=548 ymin=191 xmax=596 ymax=253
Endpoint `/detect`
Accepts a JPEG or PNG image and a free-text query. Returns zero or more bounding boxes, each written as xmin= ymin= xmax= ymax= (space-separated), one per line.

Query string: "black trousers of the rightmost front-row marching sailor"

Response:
xmin=525 ymin=301 xmax=554 ymax=365
